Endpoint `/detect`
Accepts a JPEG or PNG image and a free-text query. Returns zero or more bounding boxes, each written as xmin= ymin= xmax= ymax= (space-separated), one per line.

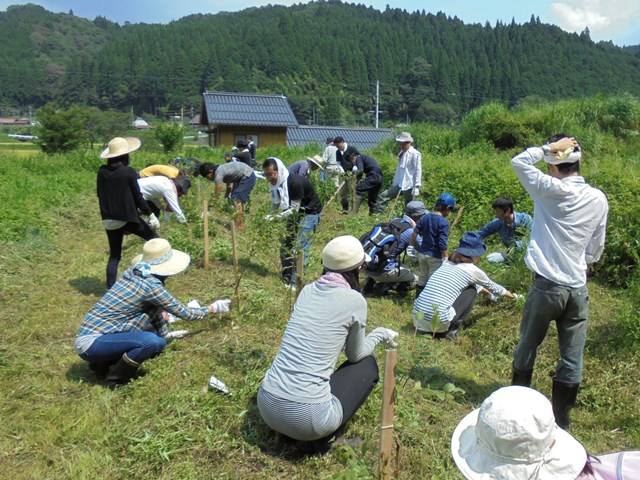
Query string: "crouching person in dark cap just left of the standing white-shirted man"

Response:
xmin=478 ymin=197 xmax=533 ymax=263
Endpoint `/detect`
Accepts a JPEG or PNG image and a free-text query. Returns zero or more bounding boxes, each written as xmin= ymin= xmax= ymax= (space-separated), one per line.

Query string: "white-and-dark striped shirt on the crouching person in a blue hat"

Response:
xmin=412 ymin=260 xmax=507 ymax=332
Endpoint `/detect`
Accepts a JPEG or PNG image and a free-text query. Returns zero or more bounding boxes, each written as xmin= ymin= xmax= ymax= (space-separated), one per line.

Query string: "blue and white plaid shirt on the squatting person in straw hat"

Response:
xmin=77 ymin=268 xmax=209 ymax=337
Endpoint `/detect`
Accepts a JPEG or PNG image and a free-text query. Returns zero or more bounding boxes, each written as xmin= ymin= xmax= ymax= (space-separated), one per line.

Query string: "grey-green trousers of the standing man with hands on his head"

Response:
xmin=513 ymin=278 xmax=589 ymax=383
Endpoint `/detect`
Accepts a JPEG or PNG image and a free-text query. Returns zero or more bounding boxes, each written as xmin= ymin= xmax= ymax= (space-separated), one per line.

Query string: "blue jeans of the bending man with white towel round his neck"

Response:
xmin=280 ymin=213 xmax=321 ymax=285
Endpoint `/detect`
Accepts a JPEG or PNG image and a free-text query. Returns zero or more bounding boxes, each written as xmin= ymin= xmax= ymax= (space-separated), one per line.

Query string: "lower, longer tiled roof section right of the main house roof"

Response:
xmin=287 ymin=125 xmax=393 ymax=151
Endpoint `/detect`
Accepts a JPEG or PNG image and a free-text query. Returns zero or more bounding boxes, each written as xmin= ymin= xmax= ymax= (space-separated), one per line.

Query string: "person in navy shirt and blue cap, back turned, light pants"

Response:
xmin=409 ymin=193 xmax=456 ymax=298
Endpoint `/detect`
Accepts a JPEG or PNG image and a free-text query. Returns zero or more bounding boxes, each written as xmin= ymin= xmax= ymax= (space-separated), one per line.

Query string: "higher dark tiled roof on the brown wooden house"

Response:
xmin=202 ymin=92 xmax=298 ymax=127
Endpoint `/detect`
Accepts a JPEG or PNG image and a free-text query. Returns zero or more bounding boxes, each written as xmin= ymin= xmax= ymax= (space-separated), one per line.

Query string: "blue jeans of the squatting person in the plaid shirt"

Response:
xmin=80 ymin=331 xmax=167 ymax=363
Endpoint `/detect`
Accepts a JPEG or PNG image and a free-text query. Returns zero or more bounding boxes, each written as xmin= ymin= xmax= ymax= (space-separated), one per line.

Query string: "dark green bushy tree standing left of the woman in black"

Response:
xmin=35 ymin=103 xmax=85 ymax=154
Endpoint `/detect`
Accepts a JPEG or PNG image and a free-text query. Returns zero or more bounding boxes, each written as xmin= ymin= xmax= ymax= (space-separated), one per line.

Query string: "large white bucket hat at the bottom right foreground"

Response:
xmin=451 ymin=386 xmax=587 ymax=480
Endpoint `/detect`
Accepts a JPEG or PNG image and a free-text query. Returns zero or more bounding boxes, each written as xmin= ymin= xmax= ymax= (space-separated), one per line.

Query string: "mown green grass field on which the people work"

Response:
xmin=0 ymin=136 xmax=640 ymax=479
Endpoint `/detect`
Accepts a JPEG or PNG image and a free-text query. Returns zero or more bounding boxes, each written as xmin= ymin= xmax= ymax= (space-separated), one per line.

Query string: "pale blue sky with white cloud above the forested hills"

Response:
xmin=0 ymin=0 xmax=640 ymax=46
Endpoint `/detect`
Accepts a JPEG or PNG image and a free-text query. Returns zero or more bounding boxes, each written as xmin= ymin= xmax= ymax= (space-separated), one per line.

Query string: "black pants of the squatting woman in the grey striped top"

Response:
xmin=329 ymin=355 xmax=380 ymax=433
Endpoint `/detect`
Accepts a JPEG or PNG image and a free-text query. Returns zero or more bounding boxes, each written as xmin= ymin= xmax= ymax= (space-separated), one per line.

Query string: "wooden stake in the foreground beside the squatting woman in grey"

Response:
xmin=380 ymin=348 xmax=398 ymax=480
